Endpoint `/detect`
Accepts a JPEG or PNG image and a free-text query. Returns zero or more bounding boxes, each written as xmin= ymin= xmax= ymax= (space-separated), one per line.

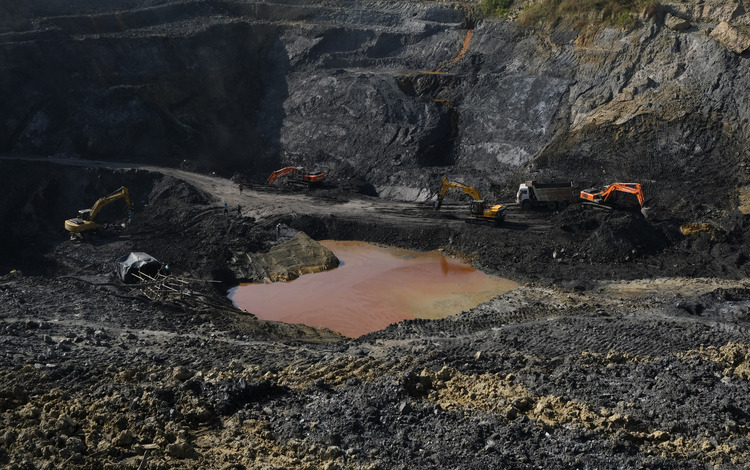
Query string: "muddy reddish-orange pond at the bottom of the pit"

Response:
xmin=229 ymin=240 xmax=518 ymax=338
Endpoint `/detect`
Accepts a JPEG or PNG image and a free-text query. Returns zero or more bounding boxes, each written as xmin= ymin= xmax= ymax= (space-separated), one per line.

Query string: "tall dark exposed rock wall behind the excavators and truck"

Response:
xmin=0 ymin=0 xmax=750 ymax=215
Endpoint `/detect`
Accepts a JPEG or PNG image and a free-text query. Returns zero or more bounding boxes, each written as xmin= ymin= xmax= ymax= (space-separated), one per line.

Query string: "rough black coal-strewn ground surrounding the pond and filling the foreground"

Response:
xmin=0 ymin=163 xmax=750 ymax=469
